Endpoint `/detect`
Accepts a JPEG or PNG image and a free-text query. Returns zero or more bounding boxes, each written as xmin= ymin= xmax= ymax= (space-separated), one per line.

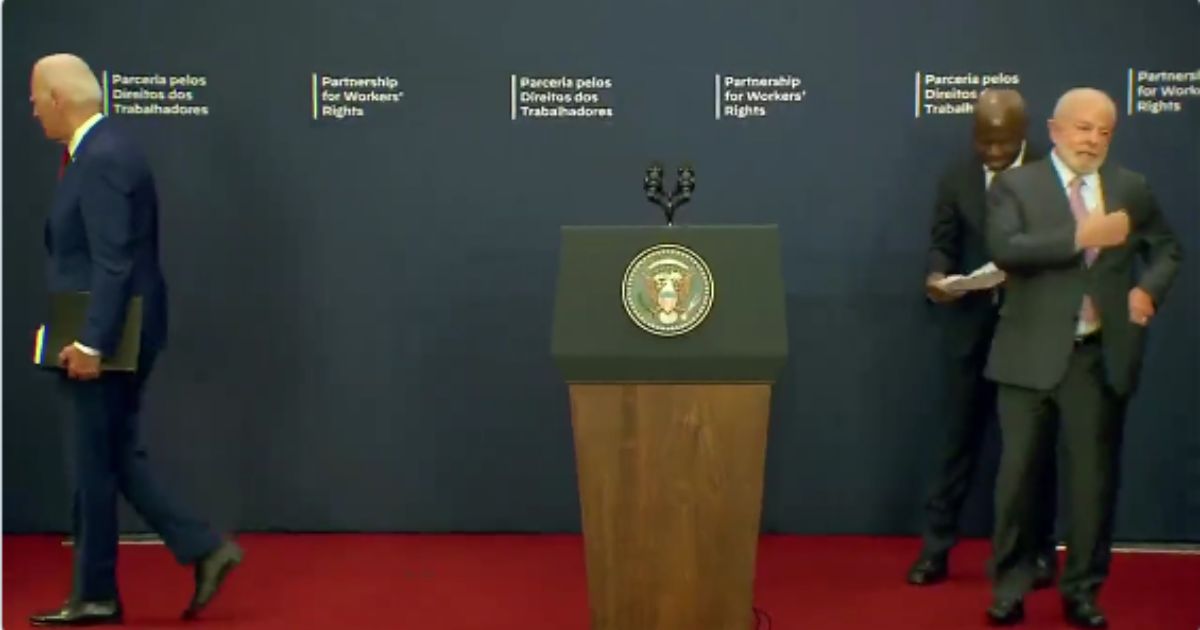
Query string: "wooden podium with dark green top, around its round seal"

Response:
xmin=552 ymin=226 xmax=787 ymax=630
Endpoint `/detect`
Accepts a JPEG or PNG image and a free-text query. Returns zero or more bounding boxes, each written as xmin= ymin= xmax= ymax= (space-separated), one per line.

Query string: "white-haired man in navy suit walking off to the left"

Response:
xmin=30 ymin=54 xmax=242 ymax=625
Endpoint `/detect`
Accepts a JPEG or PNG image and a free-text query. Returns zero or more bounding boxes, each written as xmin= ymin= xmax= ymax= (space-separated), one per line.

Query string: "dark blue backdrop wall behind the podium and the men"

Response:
xmin=4 ymin=0 xmax=1200 ymax=540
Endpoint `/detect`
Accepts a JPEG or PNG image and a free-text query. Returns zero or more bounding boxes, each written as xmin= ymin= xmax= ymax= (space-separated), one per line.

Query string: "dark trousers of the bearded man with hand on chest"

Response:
xmin=992 ymin=340 xmax=1126 ymax=599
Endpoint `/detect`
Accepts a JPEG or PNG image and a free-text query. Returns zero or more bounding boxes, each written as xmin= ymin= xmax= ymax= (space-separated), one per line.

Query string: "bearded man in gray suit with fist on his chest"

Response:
xmin=985 ymin=88 xmax=1182 ymax=628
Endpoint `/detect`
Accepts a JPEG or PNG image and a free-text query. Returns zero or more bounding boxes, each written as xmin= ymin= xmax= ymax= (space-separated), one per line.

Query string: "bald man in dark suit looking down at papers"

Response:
xmin=907 ymin=89 xmax=1056 ymax=588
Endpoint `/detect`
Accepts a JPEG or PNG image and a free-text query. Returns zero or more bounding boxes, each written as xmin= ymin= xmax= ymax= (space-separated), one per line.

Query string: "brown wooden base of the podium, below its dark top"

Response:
xmin=570 ymin=384 xmax=770 ymax=630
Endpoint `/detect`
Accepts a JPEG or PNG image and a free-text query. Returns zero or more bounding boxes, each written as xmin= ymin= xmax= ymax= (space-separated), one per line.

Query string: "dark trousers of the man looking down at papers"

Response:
xmin=922 ymin=335 xmax=1056 ymax=557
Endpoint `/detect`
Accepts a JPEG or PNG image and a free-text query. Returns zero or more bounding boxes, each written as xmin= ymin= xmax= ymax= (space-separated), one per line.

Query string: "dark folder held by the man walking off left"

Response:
xmin=34 ymin=293 xmax=142 ymax=372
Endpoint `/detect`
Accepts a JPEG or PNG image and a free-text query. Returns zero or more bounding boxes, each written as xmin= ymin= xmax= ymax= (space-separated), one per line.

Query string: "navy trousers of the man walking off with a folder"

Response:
xmin=61 ymin=350 xmax=221 ymax=601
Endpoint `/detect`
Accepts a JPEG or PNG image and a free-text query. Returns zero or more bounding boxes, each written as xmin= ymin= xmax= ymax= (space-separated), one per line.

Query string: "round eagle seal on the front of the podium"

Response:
xmin=620 ymin=244 xmax=715 ymax=337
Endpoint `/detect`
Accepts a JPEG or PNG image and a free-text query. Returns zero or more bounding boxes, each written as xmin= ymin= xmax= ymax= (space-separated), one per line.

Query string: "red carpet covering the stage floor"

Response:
xmin=4 ymin=534 xmax=1200 ymax=630
